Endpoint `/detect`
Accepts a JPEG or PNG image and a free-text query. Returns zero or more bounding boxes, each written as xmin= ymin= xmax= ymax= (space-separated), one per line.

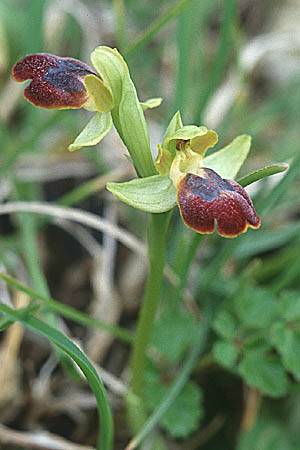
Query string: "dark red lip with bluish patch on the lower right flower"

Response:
xmin=177 ymin=168 xmax=260 ymax=237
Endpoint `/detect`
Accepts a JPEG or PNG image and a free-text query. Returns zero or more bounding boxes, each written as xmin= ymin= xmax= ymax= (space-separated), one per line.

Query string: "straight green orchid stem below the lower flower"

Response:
xmin=131 ymin=213 xmax=170 ymax=397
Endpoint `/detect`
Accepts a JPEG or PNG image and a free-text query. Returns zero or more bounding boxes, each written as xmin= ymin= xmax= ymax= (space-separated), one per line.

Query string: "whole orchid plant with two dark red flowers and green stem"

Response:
xmin=12 ymin=46 xmax=287 ymax=450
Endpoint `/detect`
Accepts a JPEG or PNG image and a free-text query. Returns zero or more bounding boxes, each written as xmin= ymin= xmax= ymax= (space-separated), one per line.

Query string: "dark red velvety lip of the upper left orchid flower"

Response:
xmin=12 ymin=53 xmax=96 ymax=109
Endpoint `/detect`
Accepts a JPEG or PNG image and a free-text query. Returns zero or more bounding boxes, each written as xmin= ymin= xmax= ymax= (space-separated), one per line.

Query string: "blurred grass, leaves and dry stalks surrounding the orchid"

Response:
xmin=0 ymin=0 xmax=300 ymax=450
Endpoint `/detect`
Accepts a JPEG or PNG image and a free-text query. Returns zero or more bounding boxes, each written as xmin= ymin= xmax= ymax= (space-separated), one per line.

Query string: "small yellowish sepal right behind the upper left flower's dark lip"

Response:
xmin=83 ymin=75 xmax=114 ymax=112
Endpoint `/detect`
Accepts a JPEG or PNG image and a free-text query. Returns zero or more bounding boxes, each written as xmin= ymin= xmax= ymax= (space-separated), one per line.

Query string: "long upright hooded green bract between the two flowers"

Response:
xmin=91 ymin=46 xmax=156 ymax=177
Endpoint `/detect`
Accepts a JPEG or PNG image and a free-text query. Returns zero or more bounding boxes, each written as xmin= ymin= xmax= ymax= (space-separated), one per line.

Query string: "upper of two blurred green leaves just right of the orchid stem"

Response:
xmin=152 ymin=308 xmax=198 ymax=363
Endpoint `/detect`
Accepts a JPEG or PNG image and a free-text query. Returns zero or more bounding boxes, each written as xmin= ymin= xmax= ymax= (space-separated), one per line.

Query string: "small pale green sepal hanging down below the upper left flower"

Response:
xmin=69 ymin=112 xmax=112 ymax=151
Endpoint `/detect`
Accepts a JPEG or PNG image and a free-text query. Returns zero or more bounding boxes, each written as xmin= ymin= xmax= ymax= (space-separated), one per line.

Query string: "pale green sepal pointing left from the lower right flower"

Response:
xmin=107 ymin=175 xmax=176 ymax=213
